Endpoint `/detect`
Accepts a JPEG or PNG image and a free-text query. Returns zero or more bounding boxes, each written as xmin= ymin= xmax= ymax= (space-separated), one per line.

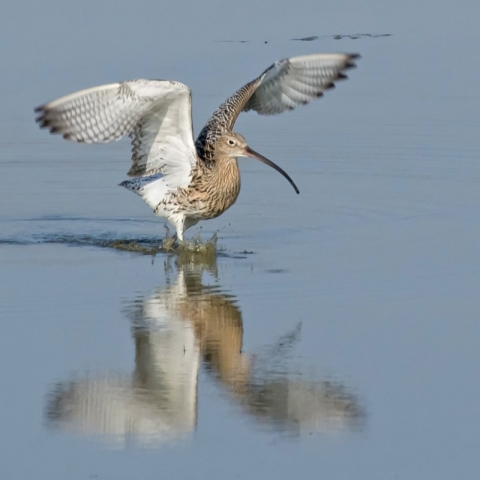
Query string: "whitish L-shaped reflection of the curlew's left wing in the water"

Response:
xmin=47 ymin=270 xmax=199 ymax=446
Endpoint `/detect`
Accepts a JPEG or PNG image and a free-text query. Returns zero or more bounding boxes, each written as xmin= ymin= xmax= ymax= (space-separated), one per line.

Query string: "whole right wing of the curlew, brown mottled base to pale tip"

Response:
xmin=196 ymin=53 xmax=359 ymax=161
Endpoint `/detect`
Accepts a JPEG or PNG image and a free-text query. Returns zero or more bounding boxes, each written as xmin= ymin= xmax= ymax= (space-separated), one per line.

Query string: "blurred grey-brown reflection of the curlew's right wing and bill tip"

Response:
xmin=207 ymin=324 xmax=365 ymax=434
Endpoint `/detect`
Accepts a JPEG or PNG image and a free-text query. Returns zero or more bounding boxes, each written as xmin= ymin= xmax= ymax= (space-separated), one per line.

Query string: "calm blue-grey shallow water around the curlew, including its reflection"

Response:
xmin=0 ymin=0 xmax=480 ymax=480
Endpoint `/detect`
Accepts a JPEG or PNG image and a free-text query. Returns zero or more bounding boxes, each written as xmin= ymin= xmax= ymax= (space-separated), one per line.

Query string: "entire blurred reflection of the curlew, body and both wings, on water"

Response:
xmin=46 ymin=251 xmax=364 ymax=446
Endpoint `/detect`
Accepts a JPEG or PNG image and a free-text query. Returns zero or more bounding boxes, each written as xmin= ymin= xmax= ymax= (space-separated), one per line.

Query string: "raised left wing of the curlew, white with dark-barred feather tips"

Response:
xmin=35 ymin=80 xmax=198 ymax=184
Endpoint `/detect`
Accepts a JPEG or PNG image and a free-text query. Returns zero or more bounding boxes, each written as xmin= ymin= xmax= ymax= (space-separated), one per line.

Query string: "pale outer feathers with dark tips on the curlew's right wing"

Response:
xmin=244 ymin=53 xmax=359 ymax=115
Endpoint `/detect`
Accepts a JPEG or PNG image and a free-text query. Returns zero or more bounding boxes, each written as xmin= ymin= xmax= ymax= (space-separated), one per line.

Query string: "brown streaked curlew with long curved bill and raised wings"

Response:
xmin=35 ymin=54 xmax=358 ymax=241
